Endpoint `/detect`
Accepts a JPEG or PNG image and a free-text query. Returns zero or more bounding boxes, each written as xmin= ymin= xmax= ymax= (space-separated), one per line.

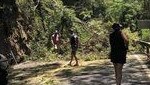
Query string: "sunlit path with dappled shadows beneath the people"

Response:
xmin=9 ymin=55 xmax=150 ymax=85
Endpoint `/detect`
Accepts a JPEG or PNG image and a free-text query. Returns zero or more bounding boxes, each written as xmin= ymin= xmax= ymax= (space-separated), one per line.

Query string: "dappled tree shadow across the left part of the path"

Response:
xmin=9 ymin=63 xmax=61 ymax=85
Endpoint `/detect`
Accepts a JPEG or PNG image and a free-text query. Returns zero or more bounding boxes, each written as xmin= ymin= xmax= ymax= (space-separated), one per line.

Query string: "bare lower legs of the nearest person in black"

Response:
xmin=116 ymin=63 xmax=123 ymax=85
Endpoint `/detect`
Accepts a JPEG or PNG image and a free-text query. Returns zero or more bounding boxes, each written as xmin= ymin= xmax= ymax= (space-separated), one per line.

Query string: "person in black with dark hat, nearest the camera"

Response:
xmin=109 ymin=23 xmax=128 ymax=85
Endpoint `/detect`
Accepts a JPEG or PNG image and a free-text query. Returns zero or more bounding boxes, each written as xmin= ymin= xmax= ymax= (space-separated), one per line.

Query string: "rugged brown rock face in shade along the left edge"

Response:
xmin=0 ymin=0 xmax=31 ymax=61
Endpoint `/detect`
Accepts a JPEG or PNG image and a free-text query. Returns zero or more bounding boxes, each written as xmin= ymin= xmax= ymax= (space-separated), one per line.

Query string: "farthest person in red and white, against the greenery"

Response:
xmin=51 ymin=30 xmax=60 ymax=52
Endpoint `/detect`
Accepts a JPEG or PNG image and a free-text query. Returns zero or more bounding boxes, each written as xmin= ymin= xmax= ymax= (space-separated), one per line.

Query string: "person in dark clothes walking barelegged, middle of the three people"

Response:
xmin=69 ymin=30 xmax=79 ymax=66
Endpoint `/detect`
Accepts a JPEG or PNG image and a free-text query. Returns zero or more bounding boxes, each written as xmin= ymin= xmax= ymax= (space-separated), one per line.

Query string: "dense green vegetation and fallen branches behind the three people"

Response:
xmin=1 ymin=0 xmax=150 ymax=60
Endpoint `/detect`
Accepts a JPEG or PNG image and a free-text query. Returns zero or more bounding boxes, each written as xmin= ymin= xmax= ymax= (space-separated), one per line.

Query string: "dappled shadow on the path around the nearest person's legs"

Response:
xmin=56 ymin=56 xmax=150 ymax=85
